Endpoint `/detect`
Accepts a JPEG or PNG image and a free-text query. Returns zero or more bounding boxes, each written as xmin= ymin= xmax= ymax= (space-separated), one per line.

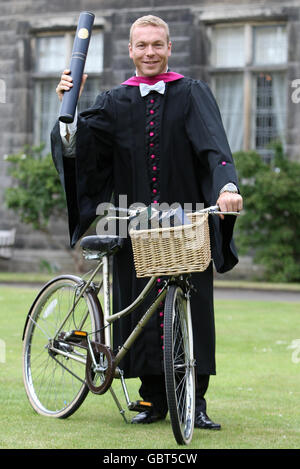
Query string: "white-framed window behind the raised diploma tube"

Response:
xmin=33 ymin=30 xmax=103 ymax=150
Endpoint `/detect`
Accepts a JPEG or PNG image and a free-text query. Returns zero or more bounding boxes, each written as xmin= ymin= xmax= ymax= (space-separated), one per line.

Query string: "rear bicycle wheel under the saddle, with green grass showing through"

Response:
xmin=23 ymin=275 xmax=103 ymax=418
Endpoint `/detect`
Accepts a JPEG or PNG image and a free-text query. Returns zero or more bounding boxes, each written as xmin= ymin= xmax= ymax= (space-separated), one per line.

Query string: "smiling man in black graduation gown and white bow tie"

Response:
xmin=52 ymin=16 xmax=242 ymax=429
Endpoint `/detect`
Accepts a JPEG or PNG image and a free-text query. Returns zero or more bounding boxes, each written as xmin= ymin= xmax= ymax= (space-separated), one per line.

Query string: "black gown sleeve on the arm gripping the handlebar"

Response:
xmin=185 ymin=81 xmax=238 ymax=273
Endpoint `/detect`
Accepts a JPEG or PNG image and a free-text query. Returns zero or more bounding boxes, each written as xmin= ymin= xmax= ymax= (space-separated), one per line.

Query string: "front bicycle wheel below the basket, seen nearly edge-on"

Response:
xmin=164 ymin=285 xmax=195 ymax=445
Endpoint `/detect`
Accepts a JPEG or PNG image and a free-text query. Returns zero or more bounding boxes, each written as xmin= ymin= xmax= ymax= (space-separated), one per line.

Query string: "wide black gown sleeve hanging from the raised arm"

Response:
xmin=51 ymin=92 xmax=114 ymax=247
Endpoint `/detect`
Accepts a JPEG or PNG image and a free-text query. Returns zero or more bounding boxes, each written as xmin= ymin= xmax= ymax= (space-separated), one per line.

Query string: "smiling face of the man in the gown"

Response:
xmin=129 ymin=25 xmax=172 ymax=77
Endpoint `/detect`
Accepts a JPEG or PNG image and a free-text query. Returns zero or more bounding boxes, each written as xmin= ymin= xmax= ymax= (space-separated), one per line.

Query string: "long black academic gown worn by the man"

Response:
xmin=51 ymin=78 xmax=238 ymax=377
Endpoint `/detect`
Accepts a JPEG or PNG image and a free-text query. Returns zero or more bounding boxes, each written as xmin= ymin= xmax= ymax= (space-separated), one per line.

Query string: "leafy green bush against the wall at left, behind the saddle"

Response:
xmin=5 ymin=145 xmax=82 ymax=271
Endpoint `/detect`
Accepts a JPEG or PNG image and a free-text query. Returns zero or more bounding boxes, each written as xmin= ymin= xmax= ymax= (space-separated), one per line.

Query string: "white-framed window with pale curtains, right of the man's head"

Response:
xmin=209 ymin=24 xmax=287 ymax=159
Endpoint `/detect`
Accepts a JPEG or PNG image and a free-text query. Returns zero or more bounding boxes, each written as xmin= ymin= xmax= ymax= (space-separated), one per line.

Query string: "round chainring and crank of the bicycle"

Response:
xmin=85 ymin=342 xmax=116 ymax=394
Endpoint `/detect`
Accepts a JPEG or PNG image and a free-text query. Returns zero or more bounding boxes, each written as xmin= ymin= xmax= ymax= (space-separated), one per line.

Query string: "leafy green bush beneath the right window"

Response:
xmin=234 ymin=142 xmax=300 ymax=282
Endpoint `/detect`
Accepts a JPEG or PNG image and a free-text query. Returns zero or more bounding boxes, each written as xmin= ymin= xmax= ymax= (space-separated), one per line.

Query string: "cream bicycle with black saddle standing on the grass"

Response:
xmin=22 ymin=206 xmax=238 ymax=445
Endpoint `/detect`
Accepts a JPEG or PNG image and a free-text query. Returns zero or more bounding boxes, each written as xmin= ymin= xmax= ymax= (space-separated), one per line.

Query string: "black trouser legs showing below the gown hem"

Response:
xmin=139 ymin=375 xmax=209 ymax=416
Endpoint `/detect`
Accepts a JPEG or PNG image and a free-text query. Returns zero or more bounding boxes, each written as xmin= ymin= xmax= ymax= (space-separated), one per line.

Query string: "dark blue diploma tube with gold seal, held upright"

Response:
xmin=59 ymin=11 xmax=95 ymax=124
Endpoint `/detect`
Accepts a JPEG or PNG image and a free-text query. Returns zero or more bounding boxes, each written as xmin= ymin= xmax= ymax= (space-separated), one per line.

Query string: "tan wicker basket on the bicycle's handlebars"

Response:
xmin=129 ymin=213 xmax=211 ymax=277
